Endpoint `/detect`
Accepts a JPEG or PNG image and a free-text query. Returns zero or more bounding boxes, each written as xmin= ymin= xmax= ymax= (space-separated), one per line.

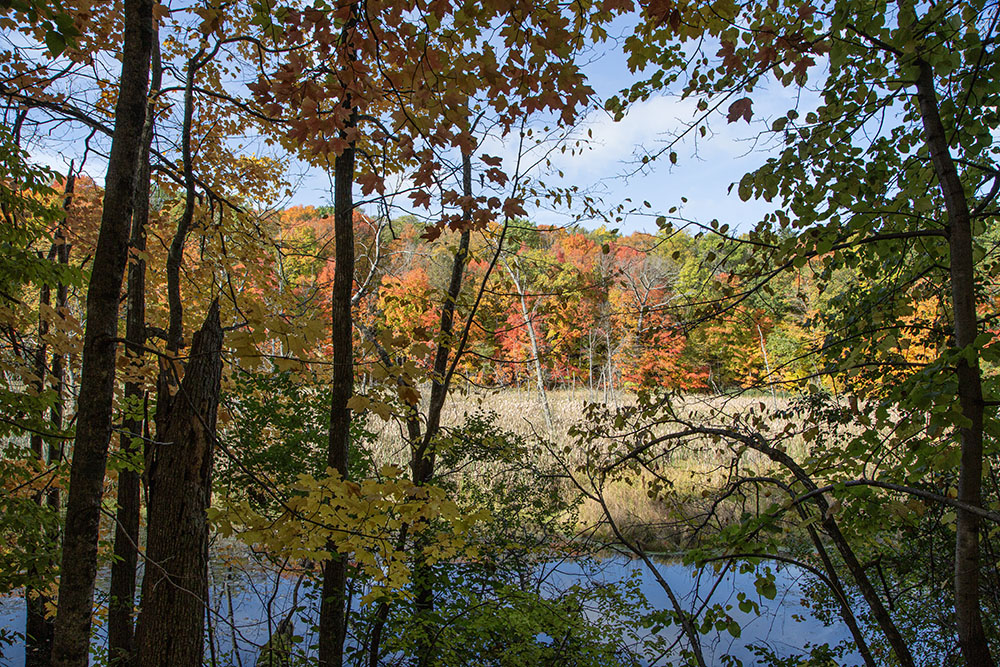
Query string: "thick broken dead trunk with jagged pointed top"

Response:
xmin=135 ymin=301 xmax=222 ymax=667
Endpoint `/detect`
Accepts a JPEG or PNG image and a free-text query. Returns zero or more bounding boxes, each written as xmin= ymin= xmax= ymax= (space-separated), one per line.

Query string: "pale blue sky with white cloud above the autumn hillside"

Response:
xmin=282 ymin=34 xmax=812 ymax=234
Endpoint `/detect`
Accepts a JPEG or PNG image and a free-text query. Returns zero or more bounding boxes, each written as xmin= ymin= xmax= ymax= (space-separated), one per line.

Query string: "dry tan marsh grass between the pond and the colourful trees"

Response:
xmin=368 ymin=389 xmax=807 ymax=551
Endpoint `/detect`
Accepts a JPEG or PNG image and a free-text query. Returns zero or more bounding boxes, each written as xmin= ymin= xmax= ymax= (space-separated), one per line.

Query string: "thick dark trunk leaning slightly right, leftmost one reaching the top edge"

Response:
xmin=52 ymin=0 xmax=153 ymax=667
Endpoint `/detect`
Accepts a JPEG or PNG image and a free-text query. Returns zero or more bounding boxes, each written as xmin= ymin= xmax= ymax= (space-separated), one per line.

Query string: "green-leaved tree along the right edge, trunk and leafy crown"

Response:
xmin=610 ymin=1 xmax=1000 ymax=665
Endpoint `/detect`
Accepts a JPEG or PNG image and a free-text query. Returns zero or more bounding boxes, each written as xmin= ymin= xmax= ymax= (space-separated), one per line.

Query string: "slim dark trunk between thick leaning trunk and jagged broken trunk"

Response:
xmin=108 ymin=38 xmax=160 ymax=666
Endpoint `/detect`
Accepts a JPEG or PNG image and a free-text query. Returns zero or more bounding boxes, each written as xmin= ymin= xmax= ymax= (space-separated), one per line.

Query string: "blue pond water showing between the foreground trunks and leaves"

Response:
xmin=0 ymin=556 xmax=861 ymax=667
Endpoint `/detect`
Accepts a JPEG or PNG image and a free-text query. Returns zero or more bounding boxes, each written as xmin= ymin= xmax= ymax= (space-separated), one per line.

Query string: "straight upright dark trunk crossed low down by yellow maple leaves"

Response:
xmin=319 ymin=103 xmax=354 ymax=667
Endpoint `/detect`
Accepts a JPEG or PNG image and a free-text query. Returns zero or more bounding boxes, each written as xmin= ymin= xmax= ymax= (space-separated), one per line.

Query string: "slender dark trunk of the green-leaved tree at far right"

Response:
xmin=917 ymin=60 xmax=995 ymax=667
